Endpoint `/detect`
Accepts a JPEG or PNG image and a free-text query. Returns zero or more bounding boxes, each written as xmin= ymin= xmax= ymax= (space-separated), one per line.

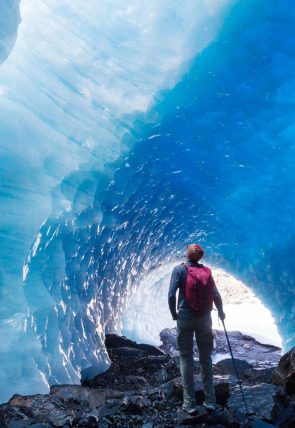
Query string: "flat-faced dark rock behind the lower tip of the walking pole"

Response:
xmin=227 ymin=383 xmax=278 ymax=421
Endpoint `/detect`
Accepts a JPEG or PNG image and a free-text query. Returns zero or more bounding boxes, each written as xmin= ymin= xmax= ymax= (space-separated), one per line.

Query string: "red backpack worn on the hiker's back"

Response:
xmin=182 ymin=263 xmax=214 ymax=314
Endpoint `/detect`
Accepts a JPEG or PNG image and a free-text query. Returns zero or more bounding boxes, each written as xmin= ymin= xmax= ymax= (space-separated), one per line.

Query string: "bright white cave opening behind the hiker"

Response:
xmin=122 ymin=263 xmax=282 ymax=347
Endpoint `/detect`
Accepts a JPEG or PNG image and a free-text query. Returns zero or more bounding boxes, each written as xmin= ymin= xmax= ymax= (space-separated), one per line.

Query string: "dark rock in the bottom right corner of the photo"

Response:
xmin=271 ymin=388 xmax=295 ymax=427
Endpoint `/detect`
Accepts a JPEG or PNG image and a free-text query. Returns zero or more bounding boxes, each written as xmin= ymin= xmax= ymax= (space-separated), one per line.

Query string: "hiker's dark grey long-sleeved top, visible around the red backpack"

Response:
xmin=168 ymin=259 xmax=223 ymax=319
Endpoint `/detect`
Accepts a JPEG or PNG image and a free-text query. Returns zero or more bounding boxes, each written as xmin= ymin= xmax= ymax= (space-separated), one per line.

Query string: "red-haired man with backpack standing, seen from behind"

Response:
xmin=168 ymin=244 xmax=225 ymax=414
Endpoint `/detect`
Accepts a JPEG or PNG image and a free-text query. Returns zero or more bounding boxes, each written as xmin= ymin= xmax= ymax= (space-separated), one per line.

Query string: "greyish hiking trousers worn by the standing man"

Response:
xmin=176 ymin=314 xmax=216 ymax=407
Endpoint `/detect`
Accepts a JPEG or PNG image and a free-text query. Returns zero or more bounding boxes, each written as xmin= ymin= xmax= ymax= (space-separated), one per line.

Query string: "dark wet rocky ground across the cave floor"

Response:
xmin=0 ymin=329 xmax=295 ymax=428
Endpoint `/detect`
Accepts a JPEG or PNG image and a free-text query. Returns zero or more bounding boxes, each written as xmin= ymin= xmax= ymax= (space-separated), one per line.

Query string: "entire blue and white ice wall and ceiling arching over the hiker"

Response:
xmin=0 ymin=0 xmax=295 ymax=401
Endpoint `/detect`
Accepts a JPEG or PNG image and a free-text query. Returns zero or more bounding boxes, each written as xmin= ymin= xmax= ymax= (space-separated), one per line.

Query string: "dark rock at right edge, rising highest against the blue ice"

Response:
xmin=272 ymin=346 xmax=295 ymax=395
